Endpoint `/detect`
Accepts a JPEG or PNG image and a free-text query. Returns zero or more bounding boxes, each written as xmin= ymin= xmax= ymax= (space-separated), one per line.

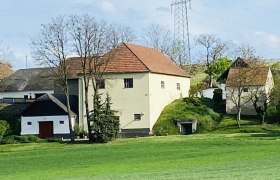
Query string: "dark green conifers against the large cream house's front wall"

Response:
xmin=90 ymin=94 xmax=120 ymax=143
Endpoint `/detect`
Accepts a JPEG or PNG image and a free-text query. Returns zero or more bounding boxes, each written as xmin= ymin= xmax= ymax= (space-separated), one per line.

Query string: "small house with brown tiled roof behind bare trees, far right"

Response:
xmin=226 ymin=67 xmax=274 ymax=115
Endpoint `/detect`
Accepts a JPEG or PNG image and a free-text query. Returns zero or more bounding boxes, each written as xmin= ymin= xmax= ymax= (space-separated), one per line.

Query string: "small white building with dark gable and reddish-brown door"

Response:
xmin=21 ymin=94 xmax=78 ymax=139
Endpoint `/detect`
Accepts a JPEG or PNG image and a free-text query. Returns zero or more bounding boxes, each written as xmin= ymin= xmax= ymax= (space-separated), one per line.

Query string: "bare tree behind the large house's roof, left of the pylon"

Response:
xmin=144 ymin=24 xmax=179 ymax=65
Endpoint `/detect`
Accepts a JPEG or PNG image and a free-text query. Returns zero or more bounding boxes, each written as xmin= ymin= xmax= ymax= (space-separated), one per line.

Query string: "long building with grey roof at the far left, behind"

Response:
xmin=0 ymin=68 xmax=54 ymax=101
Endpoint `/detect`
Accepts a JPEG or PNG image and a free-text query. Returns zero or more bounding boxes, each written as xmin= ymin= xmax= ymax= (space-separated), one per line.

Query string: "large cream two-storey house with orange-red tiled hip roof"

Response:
xmin=76 ymin=43 xmax=190 ymax=135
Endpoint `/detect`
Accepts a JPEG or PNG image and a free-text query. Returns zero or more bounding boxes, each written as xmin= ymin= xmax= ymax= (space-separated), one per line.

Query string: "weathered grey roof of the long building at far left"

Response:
xmin=0 ymin=68 xmax=54 ymax=92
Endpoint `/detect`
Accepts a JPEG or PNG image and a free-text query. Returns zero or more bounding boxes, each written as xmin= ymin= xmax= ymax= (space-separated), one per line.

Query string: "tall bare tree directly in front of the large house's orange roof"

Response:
xmin=69 ymin=15 xmax=128 ymax=142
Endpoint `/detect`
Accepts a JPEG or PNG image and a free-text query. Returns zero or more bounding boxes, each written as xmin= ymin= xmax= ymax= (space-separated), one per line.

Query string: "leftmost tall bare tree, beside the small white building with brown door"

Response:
xmin=31 ymin=16 xmax=74 ymax=142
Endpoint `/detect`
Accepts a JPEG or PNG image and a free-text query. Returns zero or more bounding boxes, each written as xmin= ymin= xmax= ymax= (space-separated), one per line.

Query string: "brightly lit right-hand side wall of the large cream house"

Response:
xmin=149 ymin=73 xmax=190 ymax=129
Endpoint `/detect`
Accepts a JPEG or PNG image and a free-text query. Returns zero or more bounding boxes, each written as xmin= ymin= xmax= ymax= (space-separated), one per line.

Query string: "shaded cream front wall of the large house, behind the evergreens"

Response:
xmin=84 ymin=73 xmax=150 ymax=129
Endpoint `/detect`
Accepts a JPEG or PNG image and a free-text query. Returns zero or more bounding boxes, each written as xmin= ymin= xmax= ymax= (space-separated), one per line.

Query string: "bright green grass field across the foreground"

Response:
xmin=0 ymin=134 xmax=280 ymax=180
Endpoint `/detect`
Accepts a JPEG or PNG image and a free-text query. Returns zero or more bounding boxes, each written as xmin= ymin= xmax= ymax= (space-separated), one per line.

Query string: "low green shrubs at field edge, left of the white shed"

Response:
xmin=1 ymin=135 xmax=39 ymax=144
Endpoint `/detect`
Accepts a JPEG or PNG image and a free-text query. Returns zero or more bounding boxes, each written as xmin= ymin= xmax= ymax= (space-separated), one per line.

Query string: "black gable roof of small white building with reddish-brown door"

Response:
xmin=22 ymin=94 xmax=78 ymax=117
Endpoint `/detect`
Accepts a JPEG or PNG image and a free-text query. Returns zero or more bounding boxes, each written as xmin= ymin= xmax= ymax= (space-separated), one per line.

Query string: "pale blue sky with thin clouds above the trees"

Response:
xmin=0 ymin=0 xmax=280 ymax=69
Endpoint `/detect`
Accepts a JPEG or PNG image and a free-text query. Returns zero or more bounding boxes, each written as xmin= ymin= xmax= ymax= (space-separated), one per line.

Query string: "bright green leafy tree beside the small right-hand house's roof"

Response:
xmin=205 ymin=57 xmax=232 ymax=78
